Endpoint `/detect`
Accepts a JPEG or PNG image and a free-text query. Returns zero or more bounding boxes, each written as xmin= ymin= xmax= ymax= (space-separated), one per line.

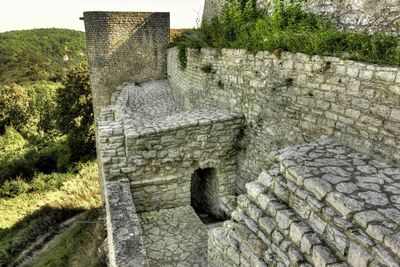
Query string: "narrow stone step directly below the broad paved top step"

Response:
xmin=258 ymin=173 xmax=398 ymax=266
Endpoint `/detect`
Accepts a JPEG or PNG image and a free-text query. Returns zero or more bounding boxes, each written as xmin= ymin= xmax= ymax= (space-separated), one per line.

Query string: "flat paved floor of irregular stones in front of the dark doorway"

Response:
xmin=139 ymin=206 xmax=207 ymax=267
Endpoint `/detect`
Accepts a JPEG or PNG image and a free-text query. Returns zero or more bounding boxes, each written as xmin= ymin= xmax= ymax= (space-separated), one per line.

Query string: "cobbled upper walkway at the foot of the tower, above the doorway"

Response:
xmin=113 ymin=80 xmax=241 ymax=136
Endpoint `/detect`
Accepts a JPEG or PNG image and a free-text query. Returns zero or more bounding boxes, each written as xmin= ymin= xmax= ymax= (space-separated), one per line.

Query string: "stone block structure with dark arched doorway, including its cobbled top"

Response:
xmin=99 ymin=82 xmax=242 ymax=217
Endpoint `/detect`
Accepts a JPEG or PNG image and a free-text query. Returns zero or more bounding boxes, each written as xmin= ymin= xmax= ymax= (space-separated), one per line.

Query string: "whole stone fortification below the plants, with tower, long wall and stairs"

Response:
xmin=85 ymin=1 xmax=400 ymax=266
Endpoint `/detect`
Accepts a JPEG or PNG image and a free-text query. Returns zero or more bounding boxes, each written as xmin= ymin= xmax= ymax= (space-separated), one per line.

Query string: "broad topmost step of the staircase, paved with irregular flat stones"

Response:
xmin=275 ymin=139 xmax=400 ymax=262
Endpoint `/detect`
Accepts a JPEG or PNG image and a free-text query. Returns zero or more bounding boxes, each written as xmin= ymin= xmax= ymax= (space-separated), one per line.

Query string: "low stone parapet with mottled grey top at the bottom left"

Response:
xmin=105 ymin=180 xmax=148 ymax=267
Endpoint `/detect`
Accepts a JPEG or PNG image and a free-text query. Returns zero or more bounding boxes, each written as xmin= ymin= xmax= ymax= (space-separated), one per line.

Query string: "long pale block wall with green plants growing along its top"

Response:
xmin=168 ymin=49 xmax=400 ymax=192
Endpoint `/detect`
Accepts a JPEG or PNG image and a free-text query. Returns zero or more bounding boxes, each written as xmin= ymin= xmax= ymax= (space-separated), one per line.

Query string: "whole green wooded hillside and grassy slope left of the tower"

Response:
xmin=0 ymin=29 xmax=104 ymax=266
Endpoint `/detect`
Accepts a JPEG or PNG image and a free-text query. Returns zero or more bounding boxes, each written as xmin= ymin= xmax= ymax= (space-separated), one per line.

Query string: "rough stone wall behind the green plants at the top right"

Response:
xmin=203 ymin=0 xmax=400 ymax=34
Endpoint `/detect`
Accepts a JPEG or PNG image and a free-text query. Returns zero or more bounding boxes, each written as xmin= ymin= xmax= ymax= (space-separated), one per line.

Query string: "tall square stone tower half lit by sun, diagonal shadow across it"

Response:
xmin=84 ymin=12 xmax=170 ymax=119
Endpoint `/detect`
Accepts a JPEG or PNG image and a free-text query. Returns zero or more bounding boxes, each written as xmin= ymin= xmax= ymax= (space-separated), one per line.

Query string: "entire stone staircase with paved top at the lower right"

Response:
xmin=208 ymin=140 xmax=400 ymax=267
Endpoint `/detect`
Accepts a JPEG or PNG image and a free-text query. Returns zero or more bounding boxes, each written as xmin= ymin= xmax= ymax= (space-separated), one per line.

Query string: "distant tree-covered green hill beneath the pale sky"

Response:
xmin=0 ymin=29 xmax=86 ymax=83
